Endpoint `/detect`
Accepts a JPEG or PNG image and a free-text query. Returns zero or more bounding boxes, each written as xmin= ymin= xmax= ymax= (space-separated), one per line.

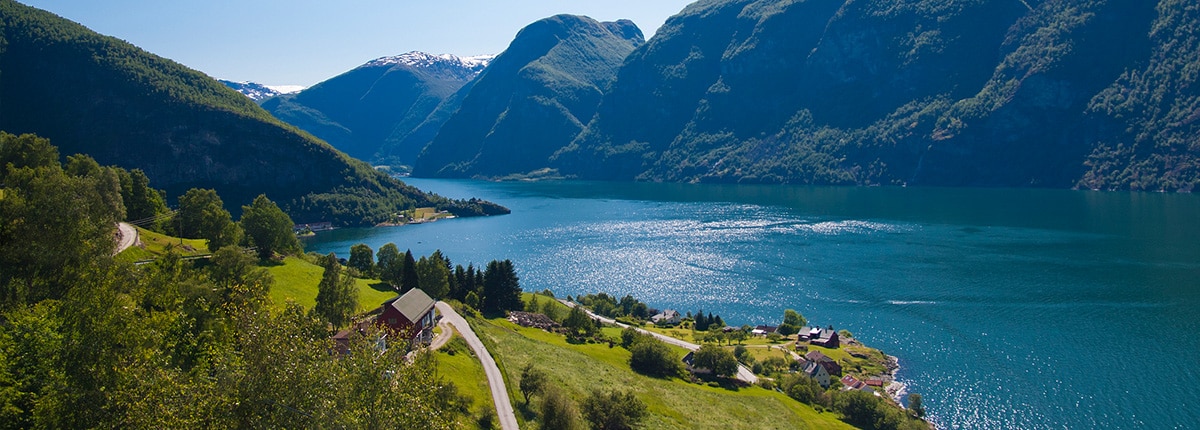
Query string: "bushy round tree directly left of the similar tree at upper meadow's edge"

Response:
xmin=172 ymin=189 xmax=242 ymax=252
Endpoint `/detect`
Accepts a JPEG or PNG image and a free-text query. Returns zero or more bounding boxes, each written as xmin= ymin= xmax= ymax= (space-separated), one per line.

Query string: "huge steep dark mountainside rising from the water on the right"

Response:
xmin=551 ymin=0 xmax=1200 ymax=191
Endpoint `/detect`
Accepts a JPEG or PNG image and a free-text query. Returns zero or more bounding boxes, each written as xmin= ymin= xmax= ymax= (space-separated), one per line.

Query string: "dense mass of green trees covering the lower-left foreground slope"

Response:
xmin=0 ymin=133 xmax=466 ymax=429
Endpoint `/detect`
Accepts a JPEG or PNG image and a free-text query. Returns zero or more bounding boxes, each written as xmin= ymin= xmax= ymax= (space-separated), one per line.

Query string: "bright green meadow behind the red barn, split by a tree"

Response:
xmin=266 ymin=257 xmax=396 ymax=312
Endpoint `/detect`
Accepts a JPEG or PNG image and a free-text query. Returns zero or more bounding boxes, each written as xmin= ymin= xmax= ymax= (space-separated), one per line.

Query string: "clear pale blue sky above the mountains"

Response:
xmin=18 ymin=0 xmax=692 ymax=85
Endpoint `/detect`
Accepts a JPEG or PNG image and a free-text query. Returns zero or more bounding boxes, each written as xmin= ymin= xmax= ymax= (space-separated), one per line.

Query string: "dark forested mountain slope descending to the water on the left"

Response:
xmin=0 ymin=0 xmax=505 ymax=225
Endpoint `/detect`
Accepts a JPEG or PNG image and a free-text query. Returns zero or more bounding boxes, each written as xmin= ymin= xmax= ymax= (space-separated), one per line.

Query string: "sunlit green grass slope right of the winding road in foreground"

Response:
xmin=473 ymin=318 xmax=851 ymax=429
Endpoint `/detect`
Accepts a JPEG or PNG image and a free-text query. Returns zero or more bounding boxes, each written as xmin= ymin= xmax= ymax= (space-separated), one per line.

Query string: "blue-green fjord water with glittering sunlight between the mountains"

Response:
xmin=307 ymin=179 xmax=1200 ymax=429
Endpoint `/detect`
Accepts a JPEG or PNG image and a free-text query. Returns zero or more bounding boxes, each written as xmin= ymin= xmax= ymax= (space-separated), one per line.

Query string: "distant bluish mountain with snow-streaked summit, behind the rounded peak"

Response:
xmin=262 ymin=52 xmax=492 ymax=165
